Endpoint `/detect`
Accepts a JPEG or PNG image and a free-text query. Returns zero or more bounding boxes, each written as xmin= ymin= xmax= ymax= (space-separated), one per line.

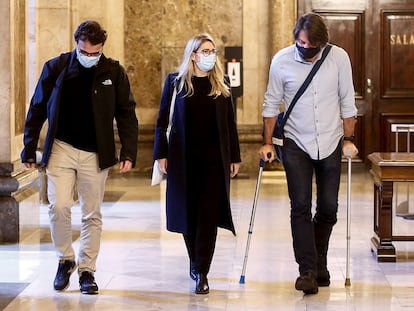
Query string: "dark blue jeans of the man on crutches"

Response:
xmin=283 ymin=139 xmax=342 ymax=274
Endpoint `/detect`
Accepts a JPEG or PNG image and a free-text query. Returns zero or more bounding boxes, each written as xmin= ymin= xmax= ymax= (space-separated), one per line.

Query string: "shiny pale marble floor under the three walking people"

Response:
xmin=0 ymin=168 xmax=414 ymax=311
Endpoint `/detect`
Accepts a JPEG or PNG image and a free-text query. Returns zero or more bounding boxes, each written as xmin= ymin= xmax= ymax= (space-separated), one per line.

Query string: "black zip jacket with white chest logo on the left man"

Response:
xmin=21 ymin=50 xmax=138 ymax=169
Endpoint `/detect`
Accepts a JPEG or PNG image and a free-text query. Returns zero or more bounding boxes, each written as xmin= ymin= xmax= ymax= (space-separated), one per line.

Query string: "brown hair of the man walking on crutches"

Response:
xmin=293 ymin=13 xmax=329 ymax=47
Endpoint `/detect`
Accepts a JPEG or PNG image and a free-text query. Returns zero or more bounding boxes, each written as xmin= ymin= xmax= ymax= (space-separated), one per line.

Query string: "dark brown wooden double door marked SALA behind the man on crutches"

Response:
xmin=298 ymin=0 xmax=414 ymax=161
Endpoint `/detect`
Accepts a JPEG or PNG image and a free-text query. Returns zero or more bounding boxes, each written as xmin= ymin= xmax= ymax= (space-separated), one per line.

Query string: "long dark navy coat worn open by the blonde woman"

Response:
xmin=153 ymin=73 xmax=241 ymax=234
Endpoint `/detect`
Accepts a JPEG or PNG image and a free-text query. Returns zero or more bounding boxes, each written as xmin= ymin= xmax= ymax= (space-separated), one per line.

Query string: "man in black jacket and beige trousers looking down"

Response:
xmin=21 ymin=21 xmax=138 ymax=294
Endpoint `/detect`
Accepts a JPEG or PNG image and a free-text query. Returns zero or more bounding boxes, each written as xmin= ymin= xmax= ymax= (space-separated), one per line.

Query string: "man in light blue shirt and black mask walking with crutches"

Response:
xmin=259 ymin=13 xmax=358 ymax=294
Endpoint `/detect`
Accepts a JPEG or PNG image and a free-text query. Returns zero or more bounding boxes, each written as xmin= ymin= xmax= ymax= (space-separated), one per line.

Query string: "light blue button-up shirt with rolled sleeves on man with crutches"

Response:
xmin=262 ymin=45 xmax=357 ymax=160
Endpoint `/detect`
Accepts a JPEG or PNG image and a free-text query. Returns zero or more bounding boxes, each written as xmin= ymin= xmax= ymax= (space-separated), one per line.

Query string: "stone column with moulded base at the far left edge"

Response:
xmin=0 ymin=0 xmax=39 ymax=243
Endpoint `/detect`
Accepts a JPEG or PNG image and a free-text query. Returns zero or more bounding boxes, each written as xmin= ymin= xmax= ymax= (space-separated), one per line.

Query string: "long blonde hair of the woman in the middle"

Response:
xmin=177 ymin=33 xmax=231 ymax=97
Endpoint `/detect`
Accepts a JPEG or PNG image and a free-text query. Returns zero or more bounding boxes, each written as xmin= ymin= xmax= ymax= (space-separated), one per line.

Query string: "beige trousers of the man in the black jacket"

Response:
xmin=46 ymin=140 xmax=108 ymax=273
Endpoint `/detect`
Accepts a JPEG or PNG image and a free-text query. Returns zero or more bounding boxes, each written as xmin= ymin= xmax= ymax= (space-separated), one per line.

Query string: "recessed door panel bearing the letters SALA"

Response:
xmin=381 ymin=10 xmax=414 ymax=98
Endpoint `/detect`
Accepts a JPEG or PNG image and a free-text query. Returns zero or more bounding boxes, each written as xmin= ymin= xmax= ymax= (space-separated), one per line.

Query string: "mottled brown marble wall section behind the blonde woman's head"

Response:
xmin=125 ymin=0 xmax=242 ymax=124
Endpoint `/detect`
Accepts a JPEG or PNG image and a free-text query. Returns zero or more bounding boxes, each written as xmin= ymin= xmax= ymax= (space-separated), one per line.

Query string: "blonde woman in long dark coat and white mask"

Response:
xmin=153 ymin=34 xmax=241 ymax=294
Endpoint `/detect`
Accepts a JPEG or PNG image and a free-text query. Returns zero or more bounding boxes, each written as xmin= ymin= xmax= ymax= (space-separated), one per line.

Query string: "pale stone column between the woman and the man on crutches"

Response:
xmin=237 ymin=0 xmax=296 ymax=176
